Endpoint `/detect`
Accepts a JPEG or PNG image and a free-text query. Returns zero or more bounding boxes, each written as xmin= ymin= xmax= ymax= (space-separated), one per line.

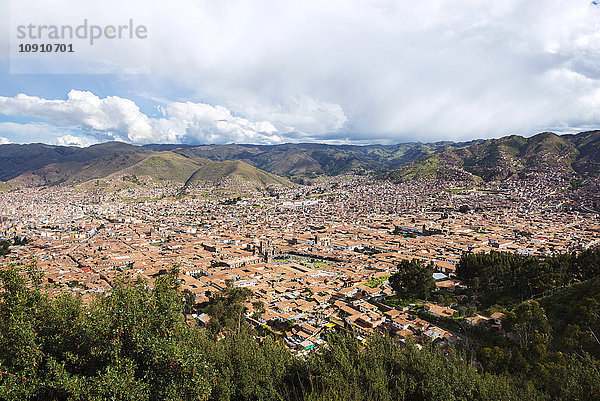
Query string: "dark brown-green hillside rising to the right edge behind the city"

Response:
xmin=382 ymin=131 xmax=600 ymax=182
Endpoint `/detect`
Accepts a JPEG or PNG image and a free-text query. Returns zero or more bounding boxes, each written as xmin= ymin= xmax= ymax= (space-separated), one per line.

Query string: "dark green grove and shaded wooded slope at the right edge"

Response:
xmin=457 ymin=248 xmax=600 ymax=360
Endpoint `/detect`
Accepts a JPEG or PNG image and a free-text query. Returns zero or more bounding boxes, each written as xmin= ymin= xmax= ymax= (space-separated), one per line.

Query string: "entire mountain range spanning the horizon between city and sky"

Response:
xmin=0 ymin=131 xmax=600 ymax=188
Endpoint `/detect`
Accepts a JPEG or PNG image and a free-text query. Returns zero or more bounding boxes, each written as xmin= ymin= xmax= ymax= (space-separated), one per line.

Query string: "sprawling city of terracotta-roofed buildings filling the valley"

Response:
xmin=0 ymin=176 xmax=600 ymax=349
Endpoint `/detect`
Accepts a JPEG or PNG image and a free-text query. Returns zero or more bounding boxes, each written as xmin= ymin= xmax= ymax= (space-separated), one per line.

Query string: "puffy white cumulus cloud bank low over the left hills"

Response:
xmin=0 ymin=90 xmax=318 ymax=146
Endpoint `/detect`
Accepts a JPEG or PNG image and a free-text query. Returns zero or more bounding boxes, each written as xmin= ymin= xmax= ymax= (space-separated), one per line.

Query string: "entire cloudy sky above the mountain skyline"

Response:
xmin=0 ymin=0 xmax=600 ymax=146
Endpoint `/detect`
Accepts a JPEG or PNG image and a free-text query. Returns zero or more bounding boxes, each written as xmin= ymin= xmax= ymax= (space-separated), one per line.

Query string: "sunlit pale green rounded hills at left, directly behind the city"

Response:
xmin=0 ymin=142 xmax=290 ymax=189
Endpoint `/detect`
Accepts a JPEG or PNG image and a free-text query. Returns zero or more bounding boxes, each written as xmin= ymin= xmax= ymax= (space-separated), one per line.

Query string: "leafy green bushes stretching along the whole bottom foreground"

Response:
xmin=0 ymin=266 xmax=600 ymax=400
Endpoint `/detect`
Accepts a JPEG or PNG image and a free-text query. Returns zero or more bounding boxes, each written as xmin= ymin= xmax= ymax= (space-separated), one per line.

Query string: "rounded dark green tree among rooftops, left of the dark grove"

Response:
xmin=389 ymin=259 xmax=435 ymax=299
